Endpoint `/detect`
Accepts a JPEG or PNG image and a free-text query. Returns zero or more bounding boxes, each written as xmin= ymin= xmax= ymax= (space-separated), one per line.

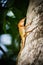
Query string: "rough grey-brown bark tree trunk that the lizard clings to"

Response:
xmin=17 ymin=0 xmax=43 ymax=65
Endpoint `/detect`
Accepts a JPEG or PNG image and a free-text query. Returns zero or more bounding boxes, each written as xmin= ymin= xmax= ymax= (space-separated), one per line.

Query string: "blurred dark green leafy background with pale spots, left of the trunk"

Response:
xmin=0 ymin=0 xmax=29 ymax=65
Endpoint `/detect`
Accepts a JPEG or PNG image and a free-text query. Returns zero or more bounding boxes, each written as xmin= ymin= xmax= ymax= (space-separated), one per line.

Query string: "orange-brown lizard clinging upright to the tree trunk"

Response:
xmin=18 ymin=17 xmax=31 ymax=50
